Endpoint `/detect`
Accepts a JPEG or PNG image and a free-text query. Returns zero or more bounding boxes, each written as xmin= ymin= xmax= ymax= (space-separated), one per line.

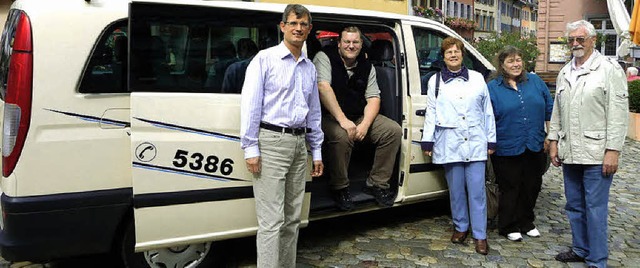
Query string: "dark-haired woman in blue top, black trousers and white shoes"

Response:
xmin=488 ymin=46 xmax=553 ymax=241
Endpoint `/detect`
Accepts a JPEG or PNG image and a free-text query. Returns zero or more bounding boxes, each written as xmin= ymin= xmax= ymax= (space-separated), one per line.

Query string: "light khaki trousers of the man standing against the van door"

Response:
xmin=253 ymin=129 xmax=310 ymax=268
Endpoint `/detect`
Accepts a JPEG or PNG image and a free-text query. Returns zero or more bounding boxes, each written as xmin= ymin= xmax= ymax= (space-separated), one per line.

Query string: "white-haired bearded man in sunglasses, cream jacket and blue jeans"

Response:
xmin=548 ymin=20 xmax=629 ymax=268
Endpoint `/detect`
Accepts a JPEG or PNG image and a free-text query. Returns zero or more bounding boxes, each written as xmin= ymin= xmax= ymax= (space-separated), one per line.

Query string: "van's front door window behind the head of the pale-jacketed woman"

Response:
xmin=413 ymin=27 xmax=490 ymax=95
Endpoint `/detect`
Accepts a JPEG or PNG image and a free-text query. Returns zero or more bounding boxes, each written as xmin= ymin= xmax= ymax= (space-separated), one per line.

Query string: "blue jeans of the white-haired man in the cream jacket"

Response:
xmin=562 ymin=164 xmax=613 ymax=267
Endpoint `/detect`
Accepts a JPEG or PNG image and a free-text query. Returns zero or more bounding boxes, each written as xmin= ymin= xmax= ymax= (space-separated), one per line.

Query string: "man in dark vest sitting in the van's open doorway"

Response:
xmin=313 ymin=26 xmax=402 ymax=210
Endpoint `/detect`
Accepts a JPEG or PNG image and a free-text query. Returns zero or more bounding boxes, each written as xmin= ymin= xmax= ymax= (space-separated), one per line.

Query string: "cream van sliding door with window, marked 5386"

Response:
xmin=129 ymin=1 xmax=300 ymax=251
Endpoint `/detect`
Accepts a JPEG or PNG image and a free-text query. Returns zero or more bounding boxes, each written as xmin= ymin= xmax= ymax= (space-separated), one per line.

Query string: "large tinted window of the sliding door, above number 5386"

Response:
xmin=130 ymin=3 xmax=281 ymax=94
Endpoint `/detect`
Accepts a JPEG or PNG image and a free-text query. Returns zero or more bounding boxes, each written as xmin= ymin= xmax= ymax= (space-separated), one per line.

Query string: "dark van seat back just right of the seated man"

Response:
xmin=368 ymin=39 xmax=398 ymax=122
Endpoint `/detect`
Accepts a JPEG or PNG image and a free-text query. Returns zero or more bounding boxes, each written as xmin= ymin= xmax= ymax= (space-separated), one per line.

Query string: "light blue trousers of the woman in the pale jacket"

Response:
xmin=444 ymin=161 xmax=487 ymax=240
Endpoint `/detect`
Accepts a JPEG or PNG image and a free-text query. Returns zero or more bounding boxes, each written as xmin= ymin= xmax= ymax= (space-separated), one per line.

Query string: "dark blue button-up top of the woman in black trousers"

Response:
xmin=487 ymin=73 xmax=553 ymax=156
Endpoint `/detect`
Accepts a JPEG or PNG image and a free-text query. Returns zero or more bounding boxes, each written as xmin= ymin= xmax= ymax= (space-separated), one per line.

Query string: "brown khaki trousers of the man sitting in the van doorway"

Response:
xmin=322 ymin=114 xmax=402 ymax=190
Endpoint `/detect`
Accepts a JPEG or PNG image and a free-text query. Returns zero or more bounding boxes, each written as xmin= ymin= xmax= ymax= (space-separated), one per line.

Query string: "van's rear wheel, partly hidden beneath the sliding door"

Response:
xmin=119 ymin=221 xmax=214 ymax=268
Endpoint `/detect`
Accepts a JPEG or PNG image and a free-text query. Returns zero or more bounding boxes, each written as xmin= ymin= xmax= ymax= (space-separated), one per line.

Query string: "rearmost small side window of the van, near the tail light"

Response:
xmin=78 ymin=20 xmax=128 ymax=93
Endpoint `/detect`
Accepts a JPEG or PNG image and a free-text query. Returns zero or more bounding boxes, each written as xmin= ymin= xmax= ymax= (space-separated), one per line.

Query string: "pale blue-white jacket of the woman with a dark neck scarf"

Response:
xmin=422 ymin=70 xmax=496 ymax=164
